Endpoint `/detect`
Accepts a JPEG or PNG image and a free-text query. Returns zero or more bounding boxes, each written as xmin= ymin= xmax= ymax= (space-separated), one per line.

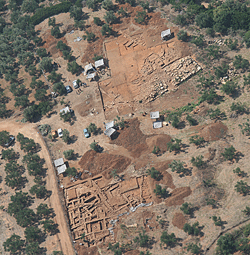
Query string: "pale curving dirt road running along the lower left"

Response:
xmin=0 ymin=120 xmax=75 ymax=255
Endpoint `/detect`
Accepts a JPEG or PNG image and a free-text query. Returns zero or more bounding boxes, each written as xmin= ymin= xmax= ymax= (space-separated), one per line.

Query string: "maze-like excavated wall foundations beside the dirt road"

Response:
xmin=64 ymin=175 xmax=152 ymax=247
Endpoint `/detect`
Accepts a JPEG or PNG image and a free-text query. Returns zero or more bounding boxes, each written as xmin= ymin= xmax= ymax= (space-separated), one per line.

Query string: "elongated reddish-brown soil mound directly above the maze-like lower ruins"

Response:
xmin=78 ymin=150 xmax=131 ymax=179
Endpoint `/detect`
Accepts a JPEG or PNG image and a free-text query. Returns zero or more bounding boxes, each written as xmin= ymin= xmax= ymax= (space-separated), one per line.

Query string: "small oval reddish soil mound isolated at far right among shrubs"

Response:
xmin=201 ymin=122 xmax=228 ymax=141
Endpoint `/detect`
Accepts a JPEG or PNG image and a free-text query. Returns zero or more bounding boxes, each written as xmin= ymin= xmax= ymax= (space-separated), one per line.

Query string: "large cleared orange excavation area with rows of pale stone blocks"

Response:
xmin=98 ymin=23 xmax=202 ymax=119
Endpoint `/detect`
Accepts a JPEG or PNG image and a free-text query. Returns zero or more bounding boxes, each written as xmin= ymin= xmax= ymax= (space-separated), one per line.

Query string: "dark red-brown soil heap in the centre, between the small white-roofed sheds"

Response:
xmin=110 ymin=118 xmax=148 ymax=158
